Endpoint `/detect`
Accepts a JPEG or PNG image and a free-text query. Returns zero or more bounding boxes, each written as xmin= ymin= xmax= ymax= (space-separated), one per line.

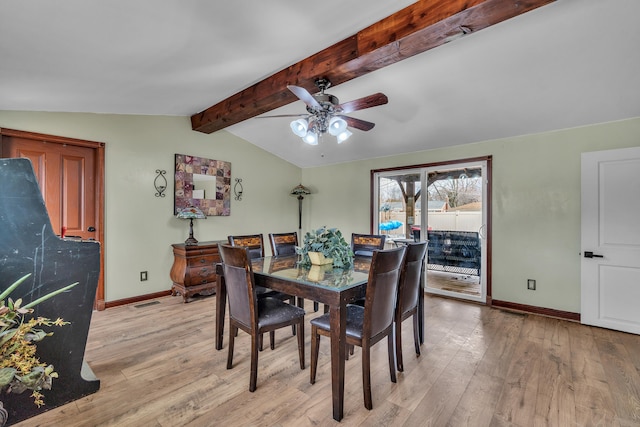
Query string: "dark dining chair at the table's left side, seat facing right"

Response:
xmin=219 ymin=245 xmax=305 ymax=392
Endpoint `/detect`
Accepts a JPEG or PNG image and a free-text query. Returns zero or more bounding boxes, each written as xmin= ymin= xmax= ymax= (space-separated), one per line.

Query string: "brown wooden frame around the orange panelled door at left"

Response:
xmin=0 ymin=128 xmax=106 ymax=311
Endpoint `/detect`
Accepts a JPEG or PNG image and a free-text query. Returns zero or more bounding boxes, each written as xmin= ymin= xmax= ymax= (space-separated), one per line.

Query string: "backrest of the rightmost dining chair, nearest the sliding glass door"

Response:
xmin=398 ymin=241 xmax=427 ymax=313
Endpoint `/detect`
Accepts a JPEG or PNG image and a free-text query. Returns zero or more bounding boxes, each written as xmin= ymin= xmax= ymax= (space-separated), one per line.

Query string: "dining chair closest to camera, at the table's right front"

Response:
xmin=310 ymin=246 xmax=406 ymax=409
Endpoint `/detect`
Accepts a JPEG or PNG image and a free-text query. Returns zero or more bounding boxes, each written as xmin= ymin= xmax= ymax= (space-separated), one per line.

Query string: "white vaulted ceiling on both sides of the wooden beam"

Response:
xmin=0 ymin=0 xmax=640 ymax=167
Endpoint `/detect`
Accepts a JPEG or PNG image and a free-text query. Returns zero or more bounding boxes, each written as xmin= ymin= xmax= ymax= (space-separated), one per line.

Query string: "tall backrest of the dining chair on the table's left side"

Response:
xmin=218 ymin=244 xmax=257 ymax=328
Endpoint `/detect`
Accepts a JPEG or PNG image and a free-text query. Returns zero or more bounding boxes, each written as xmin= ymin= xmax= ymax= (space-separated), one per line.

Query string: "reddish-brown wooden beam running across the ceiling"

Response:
xmin=191 ymin=0 xmax=555 ymax=133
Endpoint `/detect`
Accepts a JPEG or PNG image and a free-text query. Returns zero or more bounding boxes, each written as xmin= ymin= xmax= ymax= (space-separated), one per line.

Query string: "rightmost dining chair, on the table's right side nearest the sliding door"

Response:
xmin=394 ymin=241 xmax=427 ymax=372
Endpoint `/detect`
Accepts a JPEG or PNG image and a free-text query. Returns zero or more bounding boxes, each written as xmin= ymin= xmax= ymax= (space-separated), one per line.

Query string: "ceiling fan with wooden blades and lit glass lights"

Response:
xmin=263 ymin=78 xmax=389 ymax=145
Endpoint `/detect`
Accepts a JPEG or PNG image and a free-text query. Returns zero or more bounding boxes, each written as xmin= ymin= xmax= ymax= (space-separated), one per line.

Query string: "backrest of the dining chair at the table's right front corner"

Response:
xmin=362 ymin=246 xmax=406 ymax=338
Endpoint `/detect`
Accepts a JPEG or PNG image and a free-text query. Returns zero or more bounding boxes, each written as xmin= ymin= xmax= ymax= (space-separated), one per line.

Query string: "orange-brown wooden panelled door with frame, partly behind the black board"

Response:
xmin=0 ymin=129 xmax=104 ymax=310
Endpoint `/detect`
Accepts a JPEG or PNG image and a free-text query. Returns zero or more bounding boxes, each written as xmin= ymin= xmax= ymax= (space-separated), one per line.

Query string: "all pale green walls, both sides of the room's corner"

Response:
xmin=0 ymin=111 xmax=640 ymax=312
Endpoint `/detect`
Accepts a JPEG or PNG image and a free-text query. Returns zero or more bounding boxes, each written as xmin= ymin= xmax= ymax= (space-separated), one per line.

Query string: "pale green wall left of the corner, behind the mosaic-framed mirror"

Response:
xmin=0 ymin=111 xmax=301 ymax=302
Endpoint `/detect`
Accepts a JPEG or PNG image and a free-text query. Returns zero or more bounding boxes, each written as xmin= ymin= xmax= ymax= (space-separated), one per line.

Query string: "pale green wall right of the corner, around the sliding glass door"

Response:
xmin=302 ymin=118 xmax=640 ymax=312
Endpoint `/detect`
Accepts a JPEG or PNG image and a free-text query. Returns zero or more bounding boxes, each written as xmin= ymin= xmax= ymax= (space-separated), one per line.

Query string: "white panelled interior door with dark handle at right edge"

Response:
xmin=581 ymin=147 xmax=640 ymax=334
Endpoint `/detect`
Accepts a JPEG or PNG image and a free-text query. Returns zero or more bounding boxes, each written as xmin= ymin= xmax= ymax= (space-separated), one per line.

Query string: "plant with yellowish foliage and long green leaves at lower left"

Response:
xmin=0 ymin=273 xmax=78 ymax=407
